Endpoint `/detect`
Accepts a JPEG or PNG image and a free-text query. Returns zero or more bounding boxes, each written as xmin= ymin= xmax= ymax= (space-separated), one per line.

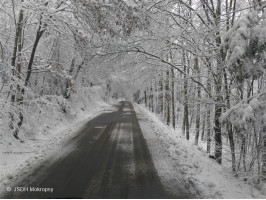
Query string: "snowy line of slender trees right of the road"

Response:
xmin=130 ymin=0 xmax=266 ymax=186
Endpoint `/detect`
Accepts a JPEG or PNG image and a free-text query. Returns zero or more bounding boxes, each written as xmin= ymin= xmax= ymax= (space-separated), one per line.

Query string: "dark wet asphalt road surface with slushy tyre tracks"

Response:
xmin=4 ymin=102 xmax=189 ymax=199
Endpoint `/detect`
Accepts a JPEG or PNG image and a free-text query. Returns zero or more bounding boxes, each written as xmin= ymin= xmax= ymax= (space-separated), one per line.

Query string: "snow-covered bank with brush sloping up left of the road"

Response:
xmin=0 ymin=86 xmax=116 ymax=193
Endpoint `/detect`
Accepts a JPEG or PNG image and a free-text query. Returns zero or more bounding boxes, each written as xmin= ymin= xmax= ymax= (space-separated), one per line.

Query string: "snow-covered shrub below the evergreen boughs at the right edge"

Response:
xmin=221 ymin=92 xmax=266 ymax=181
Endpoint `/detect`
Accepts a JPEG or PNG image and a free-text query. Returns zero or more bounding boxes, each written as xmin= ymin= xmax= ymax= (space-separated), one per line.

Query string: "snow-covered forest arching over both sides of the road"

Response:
xmin=0 ymin=0 xmax=266 ymax=189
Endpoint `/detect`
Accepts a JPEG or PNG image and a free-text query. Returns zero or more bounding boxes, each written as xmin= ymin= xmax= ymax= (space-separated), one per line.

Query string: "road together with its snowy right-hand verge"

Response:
xmin=1 ymin=102 xmax=264 ymax=198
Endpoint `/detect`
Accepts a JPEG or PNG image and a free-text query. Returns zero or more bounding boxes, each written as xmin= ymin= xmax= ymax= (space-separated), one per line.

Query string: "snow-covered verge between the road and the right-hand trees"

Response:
xmin=134 ymin=104 xmax=266 ymax=199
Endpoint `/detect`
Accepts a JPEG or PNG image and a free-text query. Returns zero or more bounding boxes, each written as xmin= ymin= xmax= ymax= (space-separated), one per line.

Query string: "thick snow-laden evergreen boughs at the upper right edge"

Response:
xmin=222 ymin=10 xmax=266 ymax=82
